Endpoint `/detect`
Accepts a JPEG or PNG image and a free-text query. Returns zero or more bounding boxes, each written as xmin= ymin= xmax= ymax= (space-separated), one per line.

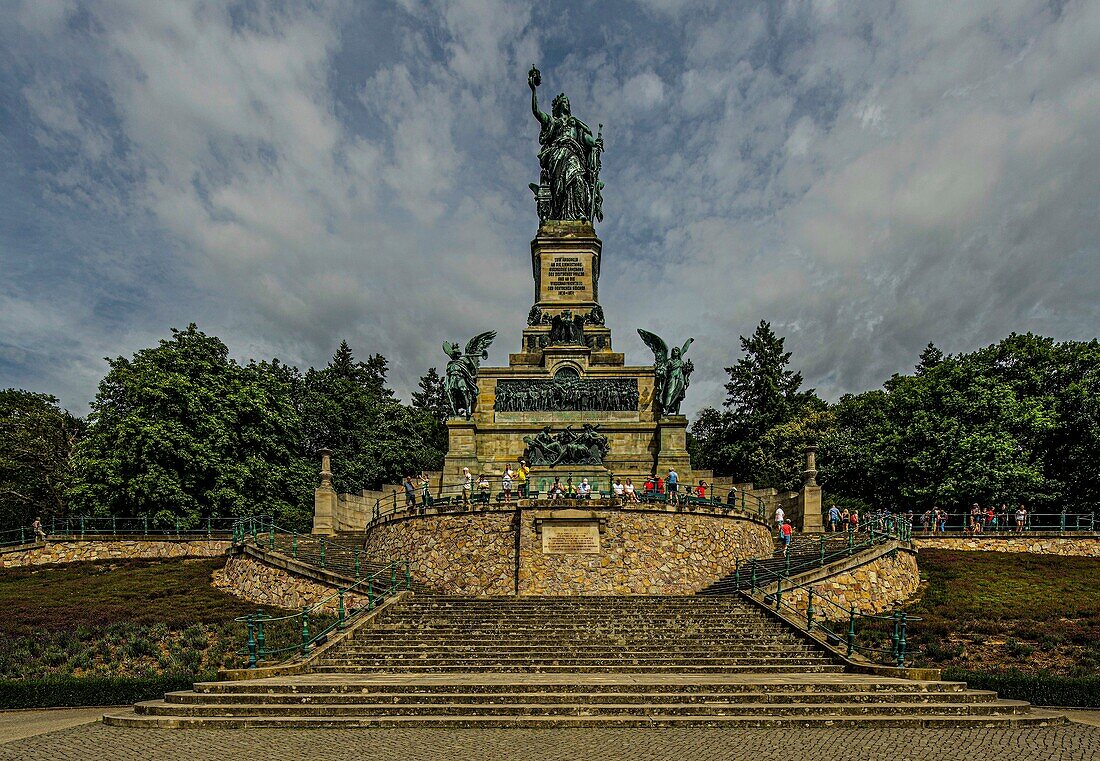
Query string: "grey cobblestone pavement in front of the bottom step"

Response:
xmin=0 ymin=724 xmax=1100 ymax=761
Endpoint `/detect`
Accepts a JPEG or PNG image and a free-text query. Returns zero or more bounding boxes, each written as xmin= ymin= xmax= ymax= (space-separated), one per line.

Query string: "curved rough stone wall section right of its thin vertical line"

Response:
xmin=519 ymin=511 xmax=773 ymax=595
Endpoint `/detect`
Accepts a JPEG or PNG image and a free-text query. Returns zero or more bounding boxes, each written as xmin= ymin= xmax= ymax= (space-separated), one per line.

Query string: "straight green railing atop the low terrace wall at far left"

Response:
xmin=0 ymin=516 xmax=239 ymax=547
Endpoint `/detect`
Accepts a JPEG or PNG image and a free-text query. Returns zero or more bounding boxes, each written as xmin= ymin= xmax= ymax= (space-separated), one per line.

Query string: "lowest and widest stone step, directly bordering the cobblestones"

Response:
xmin=103 ymin=710 xmax=1066 ymax=729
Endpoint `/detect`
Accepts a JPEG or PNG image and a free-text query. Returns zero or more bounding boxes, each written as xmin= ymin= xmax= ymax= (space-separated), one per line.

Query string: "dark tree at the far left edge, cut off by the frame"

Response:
xmin=0 ymin=388 xmax=85 ymax=531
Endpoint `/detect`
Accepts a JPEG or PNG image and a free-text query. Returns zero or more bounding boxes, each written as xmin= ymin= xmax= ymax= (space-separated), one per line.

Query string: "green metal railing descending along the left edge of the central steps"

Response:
xmin=233 ymin=561 xmax=413 ymax=669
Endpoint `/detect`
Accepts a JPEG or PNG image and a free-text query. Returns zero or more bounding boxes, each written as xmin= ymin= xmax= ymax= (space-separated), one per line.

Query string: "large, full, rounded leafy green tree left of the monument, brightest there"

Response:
xmin=67 ymin=324 xmax=309 ymax=526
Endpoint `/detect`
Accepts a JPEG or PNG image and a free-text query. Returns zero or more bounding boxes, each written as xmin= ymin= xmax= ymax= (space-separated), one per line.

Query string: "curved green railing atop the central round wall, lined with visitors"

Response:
xmin=367 ymin=473 xmax=768 ymax=528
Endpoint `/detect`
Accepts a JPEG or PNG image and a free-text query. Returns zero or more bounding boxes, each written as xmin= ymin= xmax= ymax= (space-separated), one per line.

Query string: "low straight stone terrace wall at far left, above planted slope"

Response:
xmin=0 ymin=539 xmax=232 ymax=569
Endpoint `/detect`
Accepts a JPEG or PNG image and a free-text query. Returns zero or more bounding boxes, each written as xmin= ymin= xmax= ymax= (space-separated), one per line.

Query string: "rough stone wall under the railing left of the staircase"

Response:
xmin=211 ymin=555 xmax=356 ymax=614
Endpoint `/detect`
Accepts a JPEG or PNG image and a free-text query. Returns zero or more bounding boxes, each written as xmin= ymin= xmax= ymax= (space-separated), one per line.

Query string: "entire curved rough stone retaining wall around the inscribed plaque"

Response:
xmin=365 ymin=509 xmax=773 ymax=596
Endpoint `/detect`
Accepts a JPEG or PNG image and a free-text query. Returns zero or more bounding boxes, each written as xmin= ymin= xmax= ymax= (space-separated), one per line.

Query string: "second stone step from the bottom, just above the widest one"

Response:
xmin=134 ymin=701 xmax=1030 ymax=717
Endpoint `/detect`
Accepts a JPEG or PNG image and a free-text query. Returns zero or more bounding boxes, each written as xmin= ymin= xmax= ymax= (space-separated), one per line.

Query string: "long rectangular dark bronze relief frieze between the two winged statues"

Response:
xmin=493 ymin=377 xmax=638 ymax=412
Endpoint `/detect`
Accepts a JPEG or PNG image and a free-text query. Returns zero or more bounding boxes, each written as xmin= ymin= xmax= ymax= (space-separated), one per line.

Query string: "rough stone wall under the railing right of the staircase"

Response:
xmin=769 ymin=549 xmax=921 ymax=620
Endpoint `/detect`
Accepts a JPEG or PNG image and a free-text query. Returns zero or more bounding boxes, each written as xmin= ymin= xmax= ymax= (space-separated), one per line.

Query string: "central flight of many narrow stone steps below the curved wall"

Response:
xmin=314 ymin=595 xmax=842 ymax=673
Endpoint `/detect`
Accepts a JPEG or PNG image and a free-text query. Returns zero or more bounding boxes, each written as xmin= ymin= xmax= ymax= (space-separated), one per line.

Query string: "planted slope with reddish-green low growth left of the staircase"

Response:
xmin=0 ymin=559 xmax=297 ymax=679
